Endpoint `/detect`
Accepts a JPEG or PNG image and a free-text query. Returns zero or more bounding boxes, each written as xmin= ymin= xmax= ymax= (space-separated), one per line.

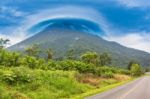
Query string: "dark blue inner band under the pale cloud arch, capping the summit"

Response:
xmin=28 ymin=18 xmax=104 ymax=34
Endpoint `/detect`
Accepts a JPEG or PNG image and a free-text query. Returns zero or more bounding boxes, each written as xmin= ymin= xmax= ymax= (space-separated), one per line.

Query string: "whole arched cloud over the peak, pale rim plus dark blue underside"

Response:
xmin=25 ymin=6 xmax=110 ymax=35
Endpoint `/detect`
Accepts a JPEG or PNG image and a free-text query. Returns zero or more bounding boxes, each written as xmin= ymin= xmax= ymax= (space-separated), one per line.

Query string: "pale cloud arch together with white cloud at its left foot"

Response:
xmin=0 ymin=6 xmax=112 ymax=45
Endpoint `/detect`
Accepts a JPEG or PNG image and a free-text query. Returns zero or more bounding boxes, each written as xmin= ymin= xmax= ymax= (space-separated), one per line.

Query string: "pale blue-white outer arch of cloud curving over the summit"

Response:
xmin=24 ymin=6 xmax=112 ymax=33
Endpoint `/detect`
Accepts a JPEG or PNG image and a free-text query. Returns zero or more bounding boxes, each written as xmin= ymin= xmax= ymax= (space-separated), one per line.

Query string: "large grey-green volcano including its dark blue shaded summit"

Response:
xmin=9 ymin=20 xmax=150 ymax=66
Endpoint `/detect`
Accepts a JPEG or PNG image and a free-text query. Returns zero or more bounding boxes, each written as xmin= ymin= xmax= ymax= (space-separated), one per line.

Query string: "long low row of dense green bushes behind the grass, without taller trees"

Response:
xmin=0 ymin=50 xmax=130 ymax=77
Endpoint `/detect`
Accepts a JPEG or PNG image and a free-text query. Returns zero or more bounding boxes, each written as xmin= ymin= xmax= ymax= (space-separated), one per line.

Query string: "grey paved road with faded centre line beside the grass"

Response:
xmin=86 ymin=76 xmax=150 ymax=99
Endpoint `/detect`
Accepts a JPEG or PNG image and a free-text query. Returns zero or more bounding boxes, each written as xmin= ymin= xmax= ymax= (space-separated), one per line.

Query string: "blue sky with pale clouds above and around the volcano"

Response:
xmin=0 ymin=0 xmax=150 ymax=52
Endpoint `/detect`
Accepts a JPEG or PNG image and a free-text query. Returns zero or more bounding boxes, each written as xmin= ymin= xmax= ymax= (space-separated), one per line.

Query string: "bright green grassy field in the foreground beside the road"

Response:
xmin=0 ymin=67 xmax=132 ymax=99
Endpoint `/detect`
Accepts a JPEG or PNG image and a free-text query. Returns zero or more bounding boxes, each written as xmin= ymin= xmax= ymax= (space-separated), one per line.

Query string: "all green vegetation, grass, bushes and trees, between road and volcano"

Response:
xmin=0 ymin=39 xmax=144 ymax=99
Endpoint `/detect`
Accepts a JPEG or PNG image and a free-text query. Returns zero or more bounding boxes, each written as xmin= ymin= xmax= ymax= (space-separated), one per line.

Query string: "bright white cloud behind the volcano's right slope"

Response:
xmin=104 ymin=33 xmax=150 ymax=52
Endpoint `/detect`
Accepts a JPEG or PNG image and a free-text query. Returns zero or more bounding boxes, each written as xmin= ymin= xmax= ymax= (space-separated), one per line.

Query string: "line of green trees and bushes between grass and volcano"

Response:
xmin=0 ymin=39 xmax=143 ymax=77
